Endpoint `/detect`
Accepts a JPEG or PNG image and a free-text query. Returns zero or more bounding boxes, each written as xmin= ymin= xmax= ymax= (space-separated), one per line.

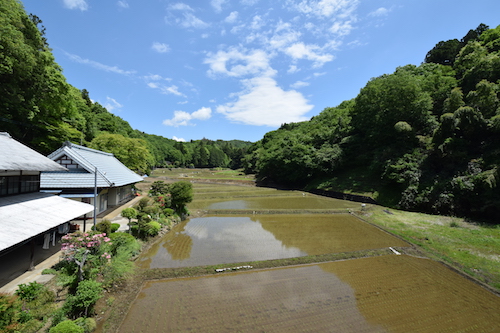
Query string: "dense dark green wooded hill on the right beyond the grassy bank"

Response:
xmin=245 ymin=24 xmax=500 ymax=223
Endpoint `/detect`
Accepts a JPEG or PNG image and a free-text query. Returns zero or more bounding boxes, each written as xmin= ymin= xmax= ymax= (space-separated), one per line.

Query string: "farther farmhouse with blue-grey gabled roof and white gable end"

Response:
xmin=40 ymin=142 xmax=143 ymax=214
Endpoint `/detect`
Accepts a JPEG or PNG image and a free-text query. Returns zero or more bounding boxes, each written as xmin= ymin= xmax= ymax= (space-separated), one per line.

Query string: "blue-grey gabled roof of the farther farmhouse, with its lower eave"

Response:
xmin=40 ymin=142 xmax=143 ymax=188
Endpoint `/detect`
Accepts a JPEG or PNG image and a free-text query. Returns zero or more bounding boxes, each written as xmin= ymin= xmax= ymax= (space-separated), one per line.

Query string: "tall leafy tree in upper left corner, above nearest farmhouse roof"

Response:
xmin=0 ymin=0 xmax=80 ymax=153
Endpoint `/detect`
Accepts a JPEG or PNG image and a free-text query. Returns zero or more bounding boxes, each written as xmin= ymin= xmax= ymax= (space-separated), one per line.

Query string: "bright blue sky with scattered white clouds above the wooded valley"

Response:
xmin=22 ymin=0 xmax=500 ymax=142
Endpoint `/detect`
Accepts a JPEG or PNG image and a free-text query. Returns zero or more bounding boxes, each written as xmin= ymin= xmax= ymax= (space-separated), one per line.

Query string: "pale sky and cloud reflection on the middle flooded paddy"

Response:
xmin=145 ymin=217 xmax=307 ymax=268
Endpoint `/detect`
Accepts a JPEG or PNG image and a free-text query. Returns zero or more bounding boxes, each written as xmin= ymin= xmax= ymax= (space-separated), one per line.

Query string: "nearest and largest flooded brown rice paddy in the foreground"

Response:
xmin=120 ymin=255 xmax=500 ymax=332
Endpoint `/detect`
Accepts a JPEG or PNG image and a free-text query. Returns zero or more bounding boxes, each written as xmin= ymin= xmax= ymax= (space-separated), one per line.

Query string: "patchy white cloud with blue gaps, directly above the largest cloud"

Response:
xmin=203 ymin=47 xmax=271 ymax=77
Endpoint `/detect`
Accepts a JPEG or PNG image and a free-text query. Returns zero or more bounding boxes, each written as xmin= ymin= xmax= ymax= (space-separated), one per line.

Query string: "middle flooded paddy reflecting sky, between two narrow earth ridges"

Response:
xmin=138 ymin=214 xmax=407 ymax=268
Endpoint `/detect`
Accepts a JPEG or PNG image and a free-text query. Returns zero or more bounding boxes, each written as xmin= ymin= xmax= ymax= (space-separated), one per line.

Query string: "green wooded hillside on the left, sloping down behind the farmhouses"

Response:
xmin=0 ymin=0 xmax=250 ymax=172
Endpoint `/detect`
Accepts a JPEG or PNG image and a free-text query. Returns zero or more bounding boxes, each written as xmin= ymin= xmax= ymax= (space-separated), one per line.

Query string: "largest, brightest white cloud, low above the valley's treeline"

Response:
xmin=217 ymin=76 xmax=313 ymax=126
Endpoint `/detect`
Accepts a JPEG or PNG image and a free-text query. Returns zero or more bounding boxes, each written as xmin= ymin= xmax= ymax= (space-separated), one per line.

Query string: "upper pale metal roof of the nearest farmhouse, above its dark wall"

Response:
xmin=0 ymin=132 xmax=67 ymax=171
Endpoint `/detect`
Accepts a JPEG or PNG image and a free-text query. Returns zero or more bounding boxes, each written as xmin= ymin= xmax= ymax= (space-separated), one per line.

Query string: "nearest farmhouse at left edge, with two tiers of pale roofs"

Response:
xmin=0 ymin=132 xmax=93 ymax=267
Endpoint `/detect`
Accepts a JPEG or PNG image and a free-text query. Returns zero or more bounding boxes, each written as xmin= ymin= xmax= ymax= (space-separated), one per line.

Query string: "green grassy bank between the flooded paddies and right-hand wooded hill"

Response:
xmin=357 ymin=206 xmax=500 ymax=291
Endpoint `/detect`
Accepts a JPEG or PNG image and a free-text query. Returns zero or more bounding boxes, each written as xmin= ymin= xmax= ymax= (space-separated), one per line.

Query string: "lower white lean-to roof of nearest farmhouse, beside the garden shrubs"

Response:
xmin=0 ymin=192 xmax=94 ymax=252
